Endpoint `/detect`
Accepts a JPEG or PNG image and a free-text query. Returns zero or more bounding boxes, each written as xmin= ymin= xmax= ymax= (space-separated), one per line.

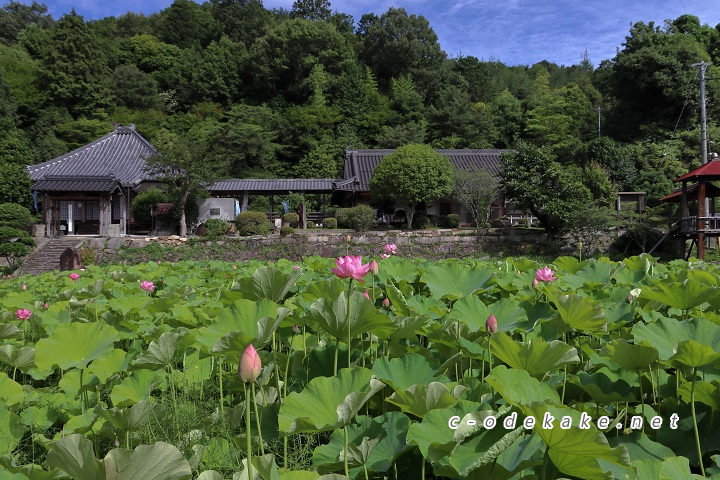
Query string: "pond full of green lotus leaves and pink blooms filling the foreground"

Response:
xmin=0 ymin=255 xmax=720 ymax=480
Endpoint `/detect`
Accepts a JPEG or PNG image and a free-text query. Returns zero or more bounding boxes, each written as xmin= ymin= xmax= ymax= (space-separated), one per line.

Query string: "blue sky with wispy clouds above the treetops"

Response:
xmin=21 ymin=0 xmax=720 ymax=65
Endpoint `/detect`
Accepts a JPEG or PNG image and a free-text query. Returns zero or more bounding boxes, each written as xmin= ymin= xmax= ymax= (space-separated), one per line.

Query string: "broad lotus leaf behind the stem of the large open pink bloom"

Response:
xmin=310 ymin=292 xmax=394 ymax=339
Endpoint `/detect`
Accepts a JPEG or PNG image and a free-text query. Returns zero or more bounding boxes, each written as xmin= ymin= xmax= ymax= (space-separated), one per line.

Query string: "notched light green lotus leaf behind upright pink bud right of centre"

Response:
xmin=449 ymin=296 xmax=528 ymax=332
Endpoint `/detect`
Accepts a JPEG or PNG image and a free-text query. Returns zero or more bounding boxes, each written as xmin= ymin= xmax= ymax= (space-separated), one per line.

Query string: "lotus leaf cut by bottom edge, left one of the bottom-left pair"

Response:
xmin=46 ymin=433 xmax=106 ymax=480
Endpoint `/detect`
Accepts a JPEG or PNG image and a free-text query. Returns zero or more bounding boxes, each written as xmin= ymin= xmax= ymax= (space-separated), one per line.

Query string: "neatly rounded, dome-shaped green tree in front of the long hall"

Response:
xmin=370 ymin=144 xmax=455 ymax=228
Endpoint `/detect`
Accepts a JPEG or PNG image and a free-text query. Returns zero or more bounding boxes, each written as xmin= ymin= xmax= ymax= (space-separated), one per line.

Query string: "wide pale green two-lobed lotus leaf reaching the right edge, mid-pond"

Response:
xmin=632 ymin=317 xmax=720 ymax=361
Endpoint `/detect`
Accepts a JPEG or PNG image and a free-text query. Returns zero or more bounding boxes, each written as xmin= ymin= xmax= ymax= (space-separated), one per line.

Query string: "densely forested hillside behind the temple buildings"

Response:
xmin=0 ymin=0 xmax=720 ymax=210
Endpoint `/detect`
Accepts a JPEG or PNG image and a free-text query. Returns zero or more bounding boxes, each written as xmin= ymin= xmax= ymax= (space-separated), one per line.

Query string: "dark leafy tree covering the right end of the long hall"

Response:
xmin=500 ymin=142 xmax=593 ymax=232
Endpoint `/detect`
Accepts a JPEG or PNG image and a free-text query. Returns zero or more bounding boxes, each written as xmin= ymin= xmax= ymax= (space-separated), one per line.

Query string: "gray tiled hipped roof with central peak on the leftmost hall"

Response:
xmin=28 ymin=126 xmax=156 ymax=190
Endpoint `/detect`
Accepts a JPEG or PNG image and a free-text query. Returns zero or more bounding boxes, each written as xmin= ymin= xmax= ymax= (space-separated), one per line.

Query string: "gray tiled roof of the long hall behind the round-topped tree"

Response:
xmin=338 ymin=150 xmax=509 ymax=192
